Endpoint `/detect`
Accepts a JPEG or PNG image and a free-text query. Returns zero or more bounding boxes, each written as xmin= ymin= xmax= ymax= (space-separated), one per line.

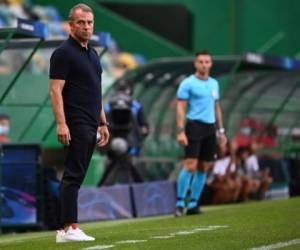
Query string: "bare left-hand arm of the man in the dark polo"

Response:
xmin=50 ymin=79 xmax=71 ymax=145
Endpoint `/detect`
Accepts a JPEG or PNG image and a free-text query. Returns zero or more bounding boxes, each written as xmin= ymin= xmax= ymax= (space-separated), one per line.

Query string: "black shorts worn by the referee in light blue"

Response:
xmin=184 ymin=120 xmax=217 ymax=161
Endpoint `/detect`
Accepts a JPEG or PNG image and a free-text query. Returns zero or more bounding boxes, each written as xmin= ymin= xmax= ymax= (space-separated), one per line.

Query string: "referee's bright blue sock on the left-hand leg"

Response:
xmin=176 ymin=168 xmax=192 ymax=207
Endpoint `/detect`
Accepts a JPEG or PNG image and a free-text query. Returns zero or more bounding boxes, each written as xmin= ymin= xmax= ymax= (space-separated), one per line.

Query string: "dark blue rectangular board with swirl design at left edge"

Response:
xmin=0 ymin=144 xmax=43 ymax=232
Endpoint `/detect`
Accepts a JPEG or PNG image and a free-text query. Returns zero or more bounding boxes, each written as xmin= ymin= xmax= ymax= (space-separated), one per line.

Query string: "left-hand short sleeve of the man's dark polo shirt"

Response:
xmin=49 ymin=49 xmax=70 ymax=80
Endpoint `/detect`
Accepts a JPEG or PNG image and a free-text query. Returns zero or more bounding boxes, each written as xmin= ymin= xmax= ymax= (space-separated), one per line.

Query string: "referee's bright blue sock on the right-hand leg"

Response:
xmin=188 ymin=171 xmax=207 ymax=209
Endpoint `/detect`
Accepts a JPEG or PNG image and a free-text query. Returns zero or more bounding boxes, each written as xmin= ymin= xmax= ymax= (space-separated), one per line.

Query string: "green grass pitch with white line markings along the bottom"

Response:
xmin=0 ymin=198 xmax=300 ymax=250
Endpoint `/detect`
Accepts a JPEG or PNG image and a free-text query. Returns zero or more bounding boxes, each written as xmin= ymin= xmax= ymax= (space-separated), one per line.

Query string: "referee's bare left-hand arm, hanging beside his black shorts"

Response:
xmin=176 ymin=99 xmax=188 ymax=146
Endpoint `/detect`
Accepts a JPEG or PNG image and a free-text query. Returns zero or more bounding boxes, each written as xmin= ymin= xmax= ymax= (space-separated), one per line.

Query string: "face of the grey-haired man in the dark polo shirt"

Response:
xmin=70 ymin=9 xmax=94 ymax=42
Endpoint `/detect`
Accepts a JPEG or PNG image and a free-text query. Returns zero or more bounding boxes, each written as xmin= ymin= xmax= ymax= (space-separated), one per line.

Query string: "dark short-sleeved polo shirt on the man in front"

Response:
xmin=49 ymin=36 xmax=102 ymax=126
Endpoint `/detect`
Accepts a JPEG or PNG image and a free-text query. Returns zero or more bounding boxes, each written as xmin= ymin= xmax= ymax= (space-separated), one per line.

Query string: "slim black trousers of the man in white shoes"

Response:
xmin=59 ymin=125 xmax=97 ymax=226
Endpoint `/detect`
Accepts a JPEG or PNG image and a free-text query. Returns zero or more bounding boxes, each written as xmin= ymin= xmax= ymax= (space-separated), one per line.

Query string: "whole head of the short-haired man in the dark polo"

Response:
xmin=69 ymin=3 xmax=94 ymax=42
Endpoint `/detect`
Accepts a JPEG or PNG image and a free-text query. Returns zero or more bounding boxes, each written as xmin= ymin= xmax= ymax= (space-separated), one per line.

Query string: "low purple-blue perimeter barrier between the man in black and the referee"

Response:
xmin=78 ymin=181 xmax=176 ymax=222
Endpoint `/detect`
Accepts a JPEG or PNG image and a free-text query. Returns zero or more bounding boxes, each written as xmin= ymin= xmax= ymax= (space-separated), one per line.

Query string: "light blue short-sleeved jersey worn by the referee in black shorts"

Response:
xmin=177 ymin=75 xmax=220 ymax=124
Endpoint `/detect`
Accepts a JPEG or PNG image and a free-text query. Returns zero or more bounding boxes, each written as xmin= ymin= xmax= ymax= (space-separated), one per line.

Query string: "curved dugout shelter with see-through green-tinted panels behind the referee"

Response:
xmin=106 ymin=53 xmax=300 ymax=184
